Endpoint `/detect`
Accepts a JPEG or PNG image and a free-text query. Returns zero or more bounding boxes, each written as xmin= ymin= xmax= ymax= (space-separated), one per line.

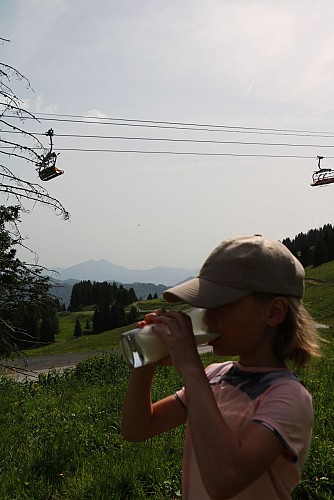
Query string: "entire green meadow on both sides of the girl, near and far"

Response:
xmin=0 ymin=274 xmax=334 ymax=500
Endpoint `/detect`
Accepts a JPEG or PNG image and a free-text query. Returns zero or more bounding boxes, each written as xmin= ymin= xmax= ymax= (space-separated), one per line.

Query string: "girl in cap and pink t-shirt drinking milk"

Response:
xmin=122 ymin=235 xmax=319 ymax=500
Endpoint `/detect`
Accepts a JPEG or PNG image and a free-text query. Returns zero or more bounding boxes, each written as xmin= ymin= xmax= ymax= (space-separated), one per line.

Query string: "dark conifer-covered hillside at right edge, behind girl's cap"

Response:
xmin=282 ymin=224 xmax=334 ymax=267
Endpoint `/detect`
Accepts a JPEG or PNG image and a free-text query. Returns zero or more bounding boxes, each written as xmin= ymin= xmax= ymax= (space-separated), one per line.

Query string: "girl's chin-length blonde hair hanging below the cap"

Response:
xmin=255 ymin=293 xmax=321 ymax=366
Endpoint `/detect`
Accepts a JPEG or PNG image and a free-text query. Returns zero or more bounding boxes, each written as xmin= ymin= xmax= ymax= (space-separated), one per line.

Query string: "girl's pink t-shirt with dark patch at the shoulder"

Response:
xmin=176 ymin=362 xmax=313 ymax=500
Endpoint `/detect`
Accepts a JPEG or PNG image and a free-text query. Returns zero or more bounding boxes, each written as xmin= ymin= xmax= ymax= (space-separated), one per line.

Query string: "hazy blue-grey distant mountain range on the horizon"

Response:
xmin=48 ymin=259 xmax=197 ymax=286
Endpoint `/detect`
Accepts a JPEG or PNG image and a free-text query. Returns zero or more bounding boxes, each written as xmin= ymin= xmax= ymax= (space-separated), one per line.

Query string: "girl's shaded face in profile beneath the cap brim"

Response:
xmin=204 ymin=294 xmax=277 ymax=366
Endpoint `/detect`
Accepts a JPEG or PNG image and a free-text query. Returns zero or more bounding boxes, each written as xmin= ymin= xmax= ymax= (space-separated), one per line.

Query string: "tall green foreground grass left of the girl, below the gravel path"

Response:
xmin=0 ymin=353 xmax=184 ymax=500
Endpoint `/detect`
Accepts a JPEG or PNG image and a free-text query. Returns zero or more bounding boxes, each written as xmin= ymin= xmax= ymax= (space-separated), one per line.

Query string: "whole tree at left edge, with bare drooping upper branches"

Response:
xmin=0 ymin=38 xmax=69 ymax=357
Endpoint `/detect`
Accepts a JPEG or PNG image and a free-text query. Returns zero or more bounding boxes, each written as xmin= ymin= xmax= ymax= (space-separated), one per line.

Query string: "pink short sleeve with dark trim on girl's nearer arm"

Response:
xmin=251 ymin=380 xmax=313 ymax=461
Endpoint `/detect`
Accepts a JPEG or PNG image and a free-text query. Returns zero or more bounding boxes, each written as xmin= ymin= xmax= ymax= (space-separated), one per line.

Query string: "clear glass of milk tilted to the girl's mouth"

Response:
xmin=121 ymin=309 xmax=219 ymax=368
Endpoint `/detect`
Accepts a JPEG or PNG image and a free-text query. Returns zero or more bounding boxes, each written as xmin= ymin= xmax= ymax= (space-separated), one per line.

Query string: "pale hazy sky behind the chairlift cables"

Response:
xmin=0 ymin=0 xmax=334 ymax=269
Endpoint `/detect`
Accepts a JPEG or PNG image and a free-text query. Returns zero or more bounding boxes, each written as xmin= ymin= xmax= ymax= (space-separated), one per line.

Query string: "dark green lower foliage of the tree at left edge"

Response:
xmin=0 ymin=206 xmax=58 ymax=357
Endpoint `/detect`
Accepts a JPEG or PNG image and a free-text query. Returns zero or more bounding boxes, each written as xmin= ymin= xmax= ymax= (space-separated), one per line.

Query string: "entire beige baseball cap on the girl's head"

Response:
xmin=163 ymin=235 xmax=305 ymax=309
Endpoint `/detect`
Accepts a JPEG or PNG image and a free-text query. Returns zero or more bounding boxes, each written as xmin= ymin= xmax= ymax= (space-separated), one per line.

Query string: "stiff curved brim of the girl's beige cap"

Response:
xmin=163 ymin=278 xmax=251 ymax=309
